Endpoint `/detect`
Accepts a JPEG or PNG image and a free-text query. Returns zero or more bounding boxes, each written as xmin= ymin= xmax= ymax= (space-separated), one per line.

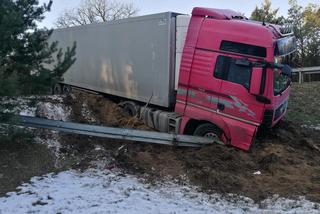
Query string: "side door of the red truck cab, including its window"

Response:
xmin=214 ymin=54 xmax=264 ymax=125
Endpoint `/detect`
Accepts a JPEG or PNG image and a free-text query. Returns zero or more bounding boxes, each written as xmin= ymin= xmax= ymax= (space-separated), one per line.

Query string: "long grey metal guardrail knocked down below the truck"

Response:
xmin=0 ymin=114 xmax=214 ymax=147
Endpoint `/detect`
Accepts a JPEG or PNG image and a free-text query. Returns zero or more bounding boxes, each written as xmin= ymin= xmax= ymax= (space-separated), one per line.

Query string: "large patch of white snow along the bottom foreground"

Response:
xmin=0 ymin=169 xmax=320 ymax=214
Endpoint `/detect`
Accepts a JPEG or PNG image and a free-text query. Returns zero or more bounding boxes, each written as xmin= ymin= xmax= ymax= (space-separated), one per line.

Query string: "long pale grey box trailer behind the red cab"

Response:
xmin=51 ymin=12 xmax=190 ymax=108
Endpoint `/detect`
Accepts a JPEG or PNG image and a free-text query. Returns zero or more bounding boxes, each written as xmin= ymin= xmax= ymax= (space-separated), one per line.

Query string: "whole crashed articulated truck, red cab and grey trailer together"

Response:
xmin=50 ymin=7 xmax=296 ymax=150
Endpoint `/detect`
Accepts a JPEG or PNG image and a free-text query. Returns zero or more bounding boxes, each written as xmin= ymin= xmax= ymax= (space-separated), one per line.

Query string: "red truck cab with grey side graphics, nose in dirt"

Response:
xmin=175 ymin=8 xmax=296 ymax=150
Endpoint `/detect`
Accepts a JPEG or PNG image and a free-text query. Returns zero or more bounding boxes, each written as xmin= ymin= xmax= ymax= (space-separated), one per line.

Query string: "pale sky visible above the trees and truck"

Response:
xmin=40 ymin=0 xmax=320 ymax=28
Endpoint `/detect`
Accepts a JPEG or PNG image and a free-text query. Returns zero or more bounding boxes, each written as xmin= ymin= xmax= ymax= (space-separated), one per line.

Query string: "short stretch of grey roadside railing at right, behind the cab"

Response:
xmin=293 ymin=66 xmax=320 ymax=84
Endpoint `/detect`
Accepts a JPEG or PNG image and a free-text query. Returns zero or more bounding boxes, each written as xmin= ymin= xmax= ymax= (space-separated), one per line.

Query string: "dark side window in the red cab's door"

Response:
xmin=214 ymin=56 xmax=252 ymax=89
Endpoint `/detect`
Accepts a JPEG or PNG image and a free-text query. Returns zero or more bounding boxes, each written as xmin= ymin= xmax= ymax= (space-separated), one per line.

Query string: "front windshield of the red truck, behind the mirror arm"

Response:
xmin=273 ymin=55 xmax=291 ymax=96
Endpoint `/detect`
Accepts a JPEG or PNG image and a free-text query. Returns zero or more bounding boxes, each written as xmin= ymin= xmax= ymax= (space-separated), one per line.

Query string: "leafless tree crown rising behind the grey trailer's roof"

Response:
xmin=55 ymin=0 xmax=138 ymax=28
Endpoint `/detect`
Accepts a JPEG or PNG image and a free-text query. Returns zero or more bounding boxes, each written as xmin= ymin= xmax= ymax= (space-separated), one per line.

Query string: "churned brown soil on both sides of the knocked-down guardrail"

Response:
xmin=62 ymin=86 xmax=320 ymax=202
